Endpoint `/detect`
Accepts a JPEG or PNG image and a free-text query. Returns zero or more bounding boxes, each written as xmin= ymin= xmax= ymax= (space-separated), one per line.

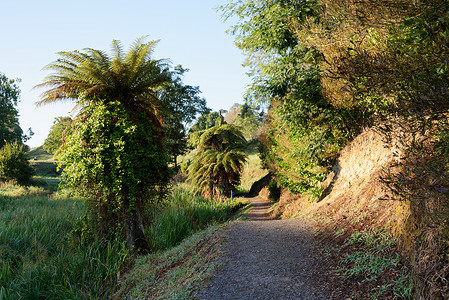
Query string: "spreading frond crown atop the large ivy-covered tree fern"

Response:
xmin=36 ymin=38 xmax=170 ymax=124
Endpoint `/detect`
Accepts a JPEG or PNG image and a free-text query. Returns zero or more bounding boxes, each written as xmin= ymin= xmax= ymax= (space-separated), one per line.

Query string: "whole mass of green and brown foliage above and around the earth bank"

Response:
xmin=221 ymin=0 xmax=449 ymax=298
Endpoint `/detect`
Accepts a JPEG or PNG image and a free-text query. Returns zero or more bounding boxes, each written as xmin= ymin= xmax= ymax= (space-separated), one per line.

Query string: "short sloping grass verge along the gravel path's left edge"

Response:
xmin=112 ymin=225 xmax=224 ymax=300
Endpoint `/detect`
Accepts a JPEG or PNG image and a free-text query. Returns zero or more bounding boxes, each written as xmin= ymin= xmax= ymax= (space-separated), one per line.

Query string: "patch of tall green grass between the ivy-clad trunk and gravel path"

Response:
xmin=147 ymin=188 xmax=245 ymax=250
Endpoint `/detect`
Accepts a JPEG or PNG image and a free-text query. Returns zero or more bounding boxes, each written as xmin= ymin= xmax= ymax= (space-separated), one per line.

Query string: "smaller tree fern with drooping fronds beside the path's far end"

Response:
xmin=188 ymin=118 xmax=247 ymax=198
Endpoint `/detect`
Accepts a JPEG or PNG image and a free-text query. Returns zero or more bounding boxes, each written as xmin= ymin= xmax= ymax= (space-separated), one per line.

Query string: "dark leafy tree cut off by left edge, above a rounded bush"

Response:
xmin=0 ymin=73 xmax=33 ymax=147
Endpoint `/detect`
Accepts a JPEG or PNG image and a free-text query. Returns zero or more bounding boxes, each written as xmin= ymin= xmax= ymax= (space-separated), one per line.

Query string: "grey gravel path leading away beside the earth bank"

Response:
xmin=196 ymin=198 xmax=327 ymax=300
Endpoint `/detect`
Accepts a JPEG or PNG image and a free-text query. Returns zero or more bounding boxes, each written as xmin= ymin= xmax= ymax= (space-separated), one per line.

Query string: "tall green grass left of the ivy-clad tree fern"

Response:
xmin=0 ymin=186 xmax=128 ymax=299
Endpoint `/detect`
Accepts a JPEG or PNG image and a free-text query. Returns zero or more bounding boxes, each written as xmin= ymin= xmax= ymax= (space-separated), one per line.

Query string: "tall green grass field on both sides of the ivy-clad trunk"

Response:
xmin=0 ymin=180 xmax=242 ymax=300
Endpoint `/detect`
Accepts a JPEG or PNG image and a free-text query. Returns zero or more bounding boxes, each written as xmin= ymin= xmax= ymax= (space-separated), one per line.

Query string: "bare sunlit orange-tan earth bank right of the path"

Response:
xmin=274 ymin=130 xmax=399 ymax=229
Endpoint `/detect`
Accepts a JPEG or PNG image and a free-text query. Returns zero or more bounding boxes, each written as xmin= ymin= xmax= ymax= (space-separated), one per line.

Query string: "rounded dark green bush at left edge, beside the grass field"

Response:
xmin=0 ymin=142 xmax=34 ymax=185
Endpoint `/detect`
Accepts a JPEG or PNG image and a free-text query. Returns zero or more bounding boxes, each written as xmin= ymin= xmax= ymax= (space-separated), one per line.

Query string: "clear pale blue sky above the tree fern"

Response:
xmin=0 ymin=0 xmax=250 ymax=147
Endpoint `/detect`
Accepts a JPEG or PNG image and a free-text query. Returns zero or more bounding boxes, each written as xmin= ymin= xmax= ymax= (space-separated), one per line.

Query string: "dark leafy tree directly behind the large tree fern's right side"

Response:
xmin=159 ymin=66 xmax=209 ymax=167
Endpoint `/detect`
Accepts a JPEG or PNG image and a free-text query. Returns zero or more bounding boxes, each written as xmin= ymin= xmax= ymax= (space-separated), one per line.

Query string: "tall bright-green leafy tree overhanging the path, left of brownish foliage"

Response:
xmin=220 ymin=0 xmax=346 ymax=192
